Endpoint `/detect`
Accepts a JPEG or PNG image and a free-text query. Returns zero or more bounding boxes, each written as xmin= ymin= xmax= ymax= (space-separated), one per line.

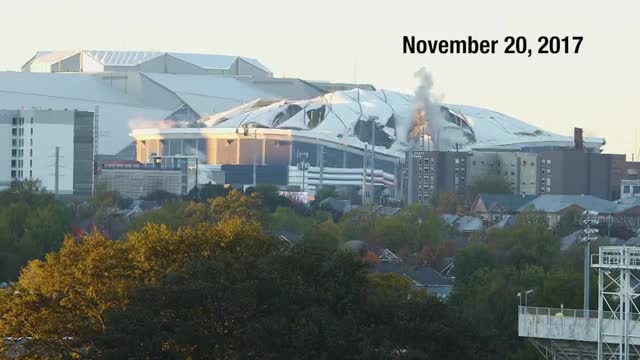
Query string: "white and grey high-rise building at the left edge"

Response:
xmin=0 ymin=110 xmax=94 ymax=196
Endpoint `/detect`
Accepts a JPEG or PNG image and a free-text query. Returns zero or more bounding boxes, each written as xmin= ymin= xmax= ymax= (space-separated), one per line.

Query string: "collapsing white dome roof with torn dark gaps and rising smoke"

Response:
xmin=191 ymin=89 xmax=604 ymax=152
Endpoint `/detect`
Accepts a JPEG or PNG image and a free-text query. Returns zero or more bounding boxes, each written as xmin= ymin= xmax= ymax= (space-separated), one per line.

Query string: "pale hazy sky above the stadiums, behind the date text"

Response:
xmin=0 ymin=0 xmax=640 ymax=158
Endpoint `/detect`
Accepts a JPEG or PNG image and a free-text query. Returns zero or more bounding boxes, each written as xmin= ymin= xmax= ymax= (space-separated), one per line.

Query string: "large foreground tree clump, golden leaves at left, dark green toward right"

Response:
xmin=0 ymin=191 xmax=488 ymax=359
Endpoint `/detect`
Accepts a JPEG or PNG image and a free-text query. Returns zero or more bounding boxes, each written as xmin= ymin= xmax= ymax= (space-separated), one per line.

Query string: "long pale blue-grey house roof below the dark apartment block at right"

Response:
xmin=518 ymin=195 xmax=616 ymax=213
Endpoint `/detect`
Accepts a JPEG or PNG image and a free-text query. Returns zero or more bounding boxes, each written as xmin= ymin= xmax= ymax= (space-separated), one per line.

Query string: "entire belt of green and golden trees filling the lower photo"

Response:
xmin=0 ymin=183 xmax=597 ymax=359
